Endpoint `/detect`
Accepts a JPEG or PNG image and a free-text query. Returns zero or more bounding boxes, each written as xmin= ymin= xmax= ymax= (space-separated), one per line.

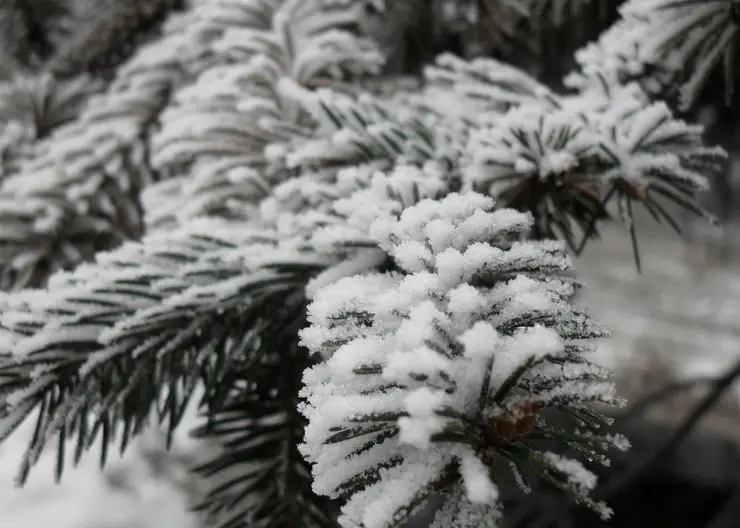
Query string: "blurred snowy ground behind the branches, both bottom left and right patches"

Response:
xmin=0 ymin=217 xmax=740 ymax=528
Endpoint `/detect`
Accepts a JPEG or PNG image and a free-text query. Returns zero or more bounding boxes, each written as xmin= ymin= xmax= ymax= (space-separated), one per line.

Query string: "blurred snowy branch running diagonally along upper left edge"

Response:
xmin=0 ymin=0 xmax=278 ymax=289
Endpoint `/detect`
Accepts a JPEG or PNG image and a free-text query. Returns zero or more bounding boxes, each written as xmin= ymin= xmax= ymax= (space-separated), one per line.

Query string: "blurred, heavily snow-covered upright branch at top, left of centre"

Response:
xmin=143 ymin=0 xmax=383 ymax=228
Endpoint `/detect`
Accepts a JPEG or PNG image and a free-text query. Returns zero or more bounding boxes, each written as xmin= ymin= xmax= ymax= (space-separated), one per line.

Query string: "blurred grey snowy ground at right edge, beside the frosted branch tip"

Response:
xmin=577 ymin=219 xmax=740 ymax=402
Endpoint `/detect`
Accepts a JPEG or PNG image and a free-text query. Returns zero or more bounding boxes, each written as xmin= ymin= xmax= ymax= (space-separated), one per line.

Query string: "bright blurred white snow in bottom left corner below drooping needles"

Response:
xmin=0 ymin=400 xmax=201 ymax=528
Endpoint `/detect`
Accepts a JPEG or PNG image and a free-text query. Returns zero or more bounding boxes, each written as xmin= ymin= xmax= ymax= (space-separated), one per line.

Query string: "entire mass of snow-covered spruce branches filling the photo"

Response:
xmin=0 ymin=0 xmax=738 ymax=528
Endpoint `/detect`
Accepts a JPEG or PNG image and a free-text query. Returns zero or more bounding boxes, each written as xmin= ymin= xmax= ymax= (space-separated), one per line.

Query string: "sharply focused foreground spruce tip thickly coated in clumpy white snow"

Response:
xmin=300 ymin=193 xmax=618 ymax=528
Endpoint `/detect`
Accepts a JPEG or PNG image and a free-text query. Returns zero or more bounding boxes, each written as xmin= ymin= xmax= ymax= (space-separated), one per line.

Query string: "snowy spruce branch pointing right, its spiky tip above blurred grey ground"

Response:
xmin=275 ymin=55 xmax=725 ymax=268
